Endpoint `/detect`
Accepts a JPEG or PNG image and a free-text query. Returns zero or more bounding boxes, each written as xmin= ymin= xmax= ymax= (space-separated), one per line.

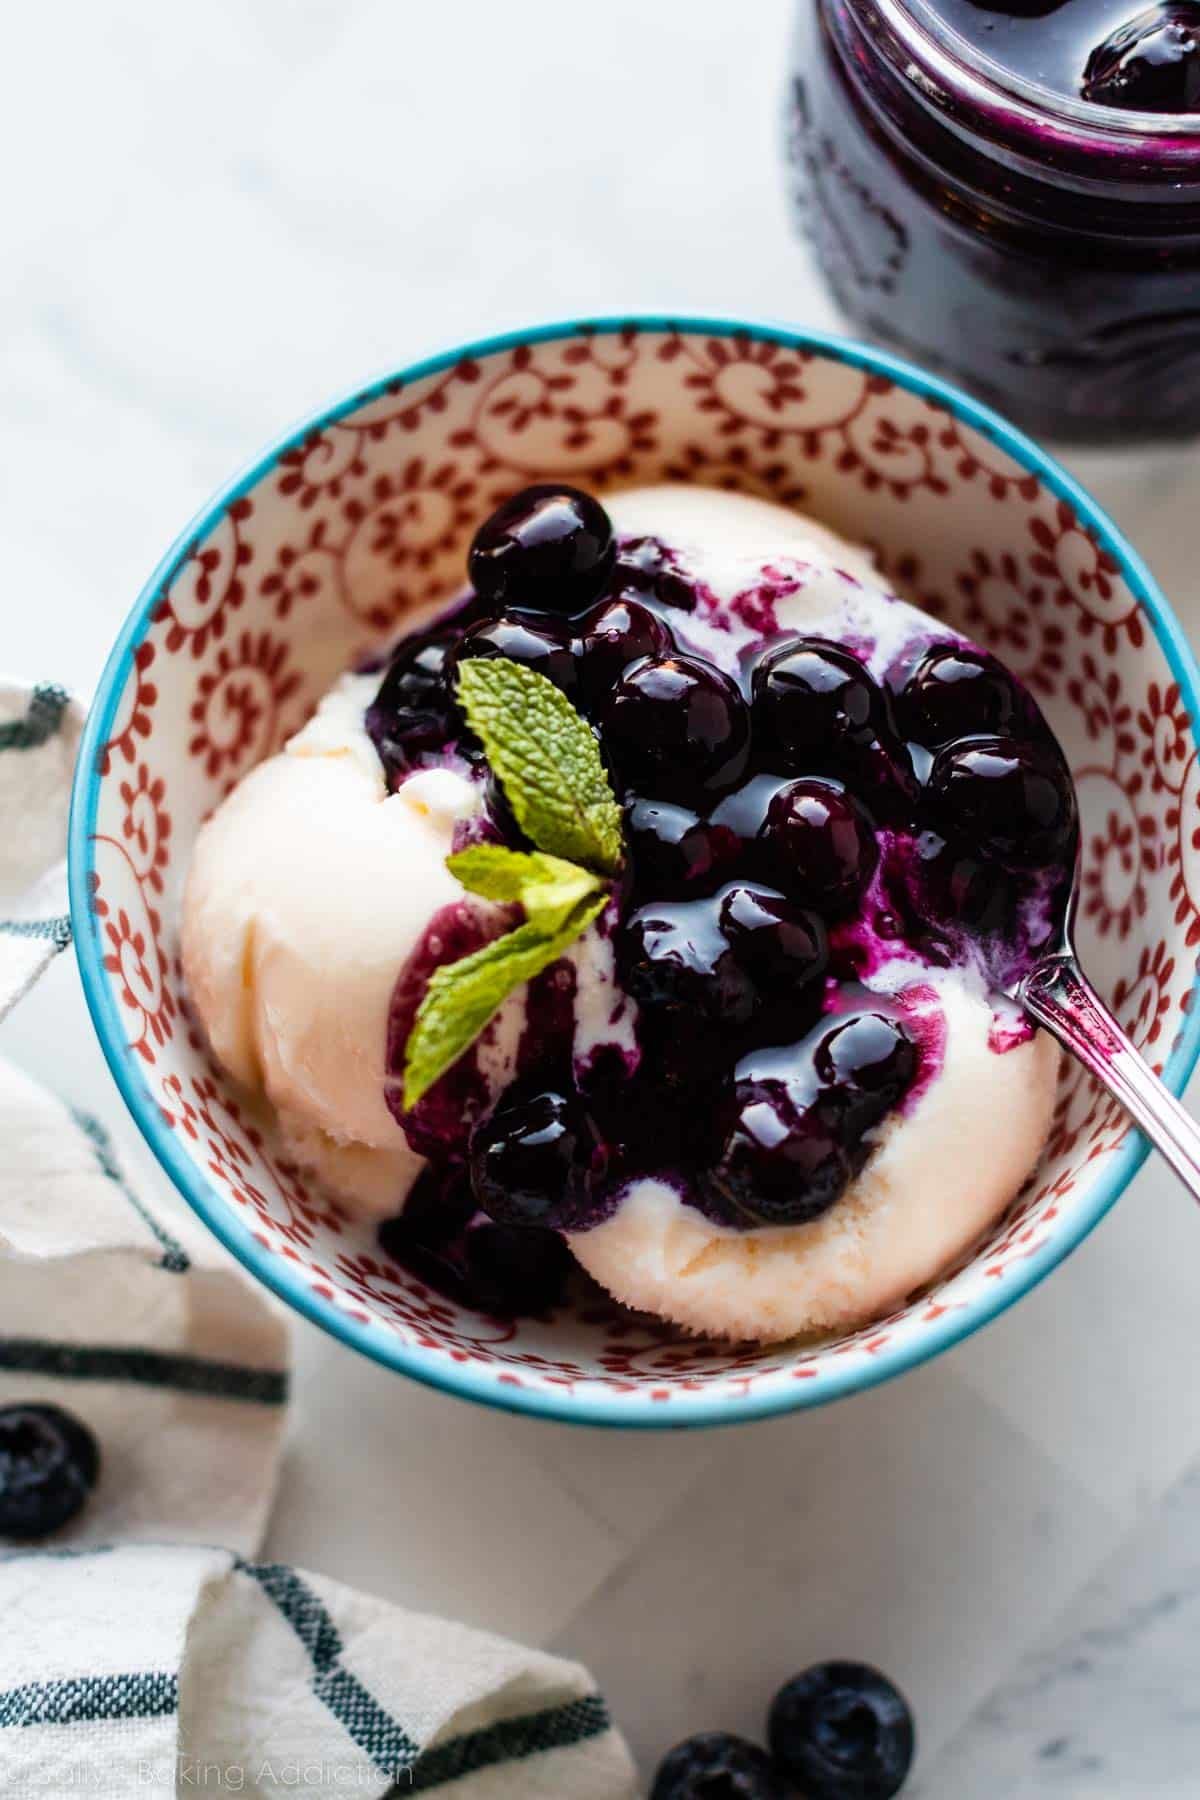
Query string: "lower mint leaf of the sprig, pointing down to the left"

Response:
xmin=405 ymin=891 xmax=608 ymax=1109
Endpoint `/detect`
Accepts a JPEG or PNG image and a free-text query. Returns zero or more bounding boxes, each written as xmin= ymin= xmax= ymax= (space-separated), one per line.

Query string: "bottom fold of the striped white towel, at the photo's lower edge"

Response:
xmin=0 ymin=1548 xmax=635 ymax=1800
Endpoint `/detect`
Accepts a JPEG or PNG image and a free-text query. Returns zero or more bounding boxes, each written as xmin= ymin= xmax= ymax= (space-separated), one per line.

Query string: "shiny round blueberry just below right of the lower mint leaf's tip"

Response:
xmin=470 ymin=1082 xmax=606 ymax=1228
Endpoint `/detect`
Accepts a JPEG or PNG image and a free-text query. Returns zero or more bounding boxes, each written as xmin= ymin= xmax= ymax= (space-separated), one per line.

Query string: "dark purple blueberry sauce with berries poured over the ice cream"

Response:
xmin=365 ymin=488 xmax=1076 ymax=1312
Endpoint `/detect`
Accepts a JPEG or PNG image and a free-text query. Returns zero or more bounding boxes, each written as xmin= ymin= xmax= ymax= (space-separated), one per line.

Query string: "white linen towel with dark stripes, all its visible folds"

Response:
xmin=0 ymin=684 xmax=635 ymax=1800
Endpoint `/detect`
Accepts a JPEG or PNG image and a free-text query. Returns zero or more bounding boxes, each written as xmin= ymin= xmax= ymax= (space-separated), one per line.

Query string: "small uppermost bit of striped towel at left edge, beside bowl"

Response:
xmin=0 ymin=682 xmax=83 ymax=1019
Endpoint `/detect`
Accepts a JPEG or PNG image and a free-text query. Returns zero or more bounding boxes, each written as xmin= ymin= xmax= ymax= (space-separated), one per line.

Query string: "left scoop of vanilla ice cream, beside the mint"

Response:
xmin=182 ymin=677 xmax=479 ymax=1217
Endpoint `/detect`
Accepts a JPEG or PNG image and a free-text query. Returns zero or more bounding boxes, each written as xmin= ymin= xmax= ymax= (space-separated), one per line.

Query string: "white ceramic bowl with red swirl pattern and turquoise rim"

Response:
xmin=70 ymin=319 xmax=1200 ymax=1426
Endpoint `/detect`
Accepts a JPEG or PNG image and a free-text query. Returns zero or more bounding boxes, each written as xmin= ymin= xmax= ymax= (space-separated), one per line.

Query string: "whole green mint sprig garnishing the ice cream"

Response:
xmin=403 ymin=657 xmax=622 ymax=1109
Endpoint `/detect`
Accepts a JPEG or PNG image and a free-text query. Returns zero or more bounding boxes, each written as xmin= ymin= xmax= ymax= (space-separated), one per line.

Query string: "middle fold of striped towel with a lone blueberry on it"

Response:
xmin=0 ymin=1060 xmax=288 ymax=1548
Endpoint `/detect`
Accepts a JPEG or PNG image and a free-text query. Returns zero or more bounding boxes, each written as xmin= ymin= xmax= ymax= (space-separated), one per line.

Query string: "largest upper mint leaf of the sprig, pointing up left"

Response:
xmin=459 ymin=657 xmax=621 ymax=875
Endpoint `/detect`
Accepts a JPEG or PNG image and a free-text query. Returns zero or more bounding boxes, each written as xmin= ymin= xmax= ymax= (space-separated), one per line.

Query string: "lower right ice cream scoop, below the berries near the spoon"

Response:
xmin=569 ymin=970 xmax=1058 ymax=1339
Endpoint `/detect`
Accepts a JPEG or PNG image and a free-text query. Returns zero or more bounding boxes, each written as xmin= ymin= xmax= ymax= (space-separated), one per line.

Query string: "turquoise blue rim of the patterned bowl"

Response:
xmin=68 ymin=313 xmax=1200 ymax=1429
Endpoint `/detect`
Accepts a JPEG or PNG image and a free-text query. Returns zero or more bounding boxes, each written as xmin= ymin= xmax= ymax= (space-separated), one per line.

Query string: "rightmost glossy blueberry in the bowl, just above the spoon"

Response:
xmin=928 ymin=738 xmax=1076 ymax=868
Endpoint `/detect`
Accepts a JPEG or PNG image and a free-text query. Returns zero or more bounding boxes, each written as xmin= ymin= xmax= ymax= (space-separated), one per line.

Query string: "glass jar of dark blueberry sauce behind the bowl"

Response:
xmin=792 ymin=0 xmax=1200 ymax=443
